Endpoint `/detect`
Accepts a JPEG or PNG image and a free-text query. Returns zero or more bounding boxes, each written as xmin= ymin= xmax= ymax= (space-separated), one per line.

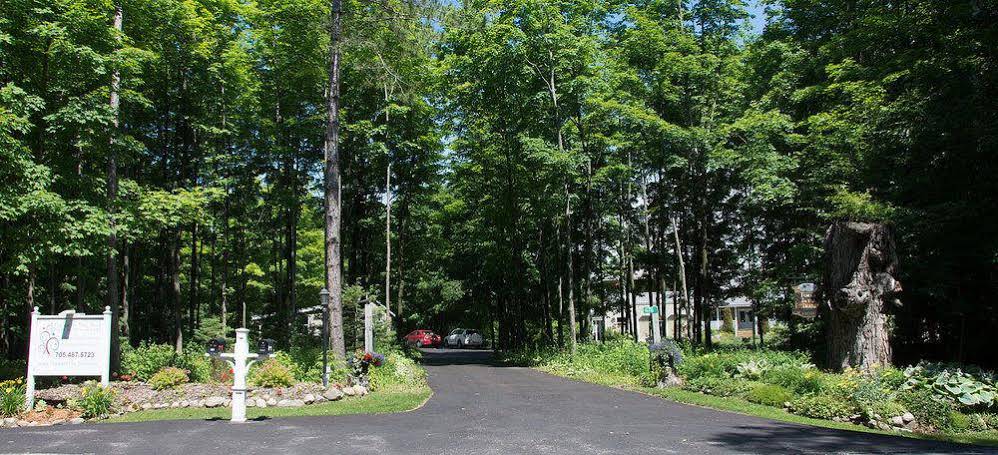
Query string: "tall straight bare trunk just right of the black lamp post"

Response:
xmin=323 ymin=0 xmax=346 ymax=360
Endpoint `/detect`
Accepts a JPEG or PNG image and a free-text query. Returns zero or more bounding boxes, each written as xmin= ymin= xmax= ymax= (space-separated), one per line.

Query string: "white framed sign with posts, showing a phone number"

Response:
xmin=25 ymin=307 xmax=112 ymax=409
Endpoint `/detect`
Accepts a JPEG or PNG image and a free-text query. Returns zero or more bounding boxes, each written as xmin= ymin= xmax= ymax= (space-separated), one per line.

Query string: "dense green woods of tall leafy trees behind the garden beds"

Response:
xmin=0 ymin=0 xmax=998 ymax=366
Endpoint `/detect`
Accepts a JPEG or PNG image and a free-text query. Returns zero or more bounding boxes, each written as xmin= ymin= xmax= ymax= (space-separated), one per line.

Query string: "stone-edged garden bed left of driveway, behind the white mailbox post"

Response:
xmin=0 ymin=345 xmax=429 ymax=428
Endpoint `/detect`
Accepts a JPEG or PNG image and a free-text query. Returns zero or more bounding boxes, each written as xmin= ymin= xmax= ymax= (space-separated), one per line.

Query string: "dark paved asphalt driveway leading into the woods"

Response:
xmin=0 ymin=350 xmax=998 ymax=455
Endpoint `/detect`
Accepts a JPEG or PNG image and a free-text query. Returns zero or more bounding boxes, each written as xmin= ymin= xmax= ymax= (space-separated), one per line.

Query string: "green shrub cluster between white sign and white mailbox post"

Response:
xmin=121 ymin=344 xmax=211 ymax=382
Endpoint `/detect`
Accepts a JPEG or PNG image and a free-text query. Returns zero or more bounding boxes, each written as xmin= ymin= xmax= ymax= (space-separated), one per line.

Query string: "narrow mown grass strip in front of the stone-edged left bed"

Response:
xmin=101 ymin=387 xmax=432 ymax=423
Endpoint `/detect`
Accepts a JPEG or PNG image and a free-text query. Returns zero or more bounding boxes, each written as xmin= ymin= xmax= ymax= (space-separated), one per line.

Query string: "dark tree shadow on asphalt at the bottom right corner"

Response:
xmin=709 ymin=425 xmax=998 ymax=454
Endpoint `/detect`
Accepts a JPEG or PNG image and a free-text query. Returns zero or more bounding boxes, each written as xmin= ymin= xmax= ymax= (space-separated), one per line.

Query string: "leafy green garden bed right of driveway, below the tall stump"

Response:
xmin=506 ymin=340 xmax=998 ymax=444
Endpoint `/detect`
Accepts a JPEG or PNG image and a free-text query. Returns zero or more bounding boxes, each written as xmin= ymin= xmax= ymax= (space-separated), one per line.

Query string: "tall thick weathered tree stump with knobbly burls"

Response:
xmin=822 ymin=222 xmax=901 ymax=371
